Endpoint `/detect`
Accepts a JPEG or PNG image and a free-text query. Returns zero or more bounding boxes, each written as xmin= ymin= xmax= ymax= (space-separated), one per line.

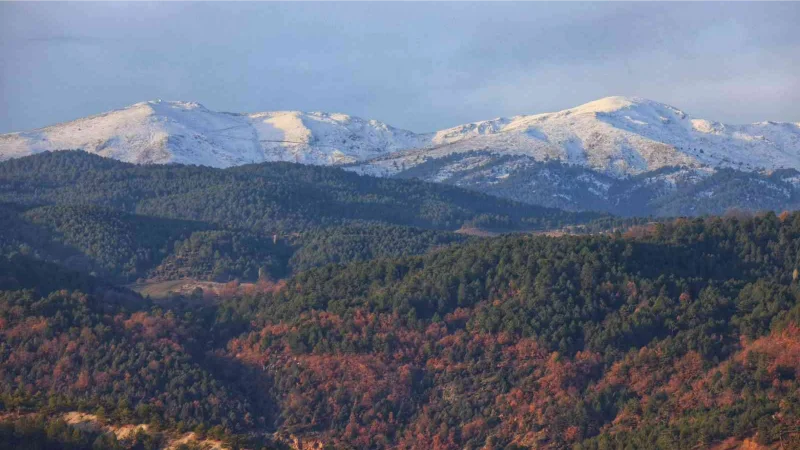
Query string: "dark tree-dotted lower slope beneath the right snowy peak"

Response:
xmin=394 ymin=155 xmax=800 ymax=217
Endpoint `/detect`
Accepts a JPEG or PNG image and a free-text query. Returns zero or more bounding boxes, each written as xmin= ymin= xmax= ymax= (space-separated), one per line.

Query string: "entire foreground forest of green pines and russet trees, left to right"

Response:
xmin=0 ymin=213 xmax=800 ymax=450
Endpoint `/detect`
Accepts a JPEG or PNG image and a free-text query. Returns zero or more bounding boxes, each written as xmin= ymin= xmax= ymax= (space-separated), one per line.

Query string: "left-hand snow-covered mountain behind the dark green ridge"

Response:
xmin=0 ymin=101 xmax=425 ymax=167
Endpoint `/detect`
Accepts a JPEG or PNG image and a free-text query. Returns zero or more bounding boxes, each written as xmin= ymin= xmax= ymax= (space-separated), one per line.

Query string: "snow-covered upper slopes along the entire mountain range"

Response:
xmin=0 ymin=97 xmax=800 ymax=181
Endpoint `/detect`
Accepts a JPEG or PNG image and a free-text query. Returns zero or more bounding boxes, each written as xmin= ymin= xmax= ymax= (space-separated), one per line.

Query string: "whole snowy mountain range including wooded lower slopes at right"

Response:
xmin=0 ymin=97 xmax=800 ymax=215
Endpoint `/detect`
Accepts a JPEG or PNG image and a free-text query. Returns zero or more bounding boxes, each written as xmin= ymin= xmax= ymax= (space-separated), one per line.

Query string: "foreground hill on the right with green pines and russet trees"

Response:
xmin=214 ymin=213 xmax=800 ymax=450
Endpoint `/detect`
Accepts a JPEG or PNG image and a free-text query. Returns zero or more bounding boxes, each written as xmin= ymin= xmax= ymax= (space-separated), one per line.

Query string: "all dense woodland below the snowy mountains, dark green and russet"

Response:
xmin=0 ymin=153 xmax=800 ymax=450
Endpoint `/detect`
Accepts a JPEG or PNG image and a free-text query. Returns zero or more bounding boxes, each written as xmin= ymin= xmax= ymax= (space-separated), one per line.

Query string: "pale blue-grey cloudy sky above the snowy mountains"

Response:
xmin=0 ymin=0 xmax=800 ymax=133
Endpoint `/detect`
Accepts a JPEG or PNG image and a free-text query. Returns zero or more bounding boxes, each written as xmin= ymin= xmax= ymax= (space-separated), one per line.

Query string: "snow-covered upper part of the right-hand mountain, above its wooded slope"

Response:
xmin=352 ymin=97 xmax=800 ymax=178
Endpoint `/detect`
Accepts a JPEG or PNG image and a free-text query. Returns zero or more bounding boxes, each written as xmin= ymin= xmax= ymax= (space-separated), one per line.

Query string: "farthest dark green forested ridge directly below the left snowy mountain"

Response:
xmin=0 ymin=151 xmax=598 ymax=232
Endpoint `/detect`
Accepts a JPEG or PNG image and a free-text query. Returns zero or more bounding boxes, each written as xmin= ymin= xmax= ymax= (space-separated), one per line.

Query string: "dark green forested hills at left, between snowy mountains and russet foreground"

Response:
xmin=0 ymin=151 xmax=609 ymax=283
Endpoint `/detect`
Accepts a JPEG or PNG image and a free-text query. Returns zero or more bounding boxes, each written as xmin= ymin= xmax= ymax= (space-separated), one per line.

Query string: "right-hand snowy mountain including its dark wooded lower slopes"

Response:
xmin=348 ymin=97 xmax=800 ymax=216
